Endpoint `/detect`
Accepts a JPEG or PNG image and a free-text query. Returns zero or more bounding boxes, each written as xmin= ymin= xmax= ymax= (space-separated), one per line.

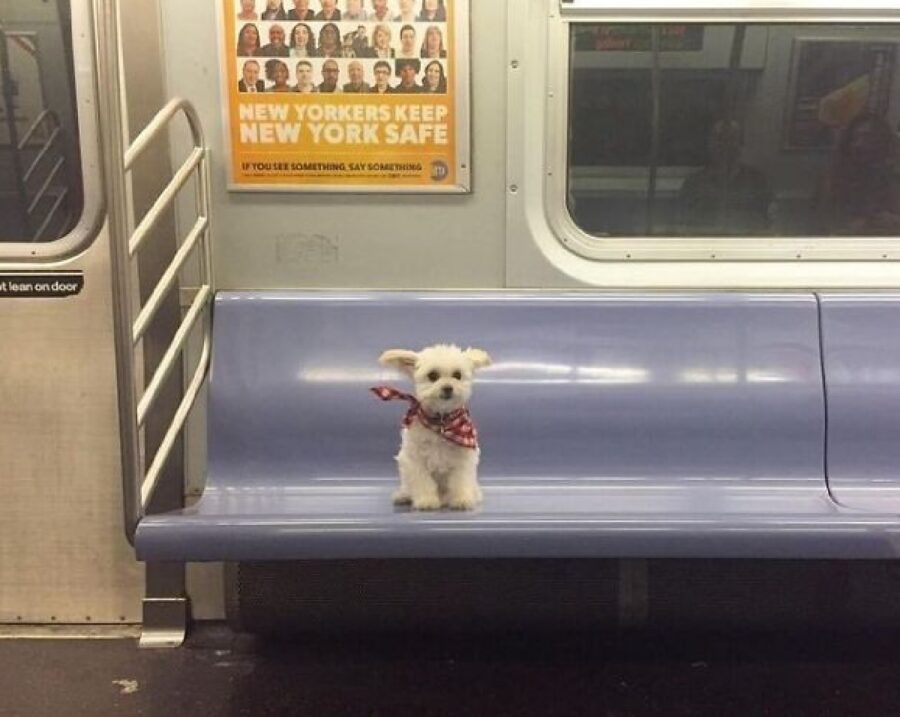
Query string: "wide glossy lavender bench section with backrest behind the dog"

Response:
xmin=136 ymin=292 xmax=898 ymax=560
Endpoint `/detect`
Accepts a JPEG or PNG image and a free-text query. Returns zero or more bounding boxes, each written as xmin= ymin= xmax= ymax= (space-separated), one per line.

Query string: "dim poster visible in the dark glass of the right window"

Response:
xmin=785 ymin=39 xmax=896 ymax=149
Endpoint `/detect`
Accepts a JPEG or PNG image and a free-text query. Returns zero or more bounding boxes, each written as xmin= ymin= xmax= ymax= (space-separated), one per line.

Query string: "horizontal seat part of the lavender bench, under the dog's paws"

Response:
xmin=138 ymin=480 xmax=900 ymax=561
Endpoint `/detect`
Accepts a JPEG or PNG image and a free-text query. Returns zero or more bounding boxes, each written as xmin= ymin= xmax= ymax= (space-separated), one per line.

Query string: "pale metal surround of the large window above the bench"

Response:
xmin=506 ymin=0 xmax=900 ymax=290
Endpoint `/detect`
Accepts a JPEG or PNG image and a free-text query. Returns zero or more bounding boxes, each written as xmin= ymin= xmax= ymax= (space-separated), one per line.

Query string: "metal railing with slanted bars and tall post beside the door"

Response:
xmin=95 ymin=0 xmax=214 ymax=543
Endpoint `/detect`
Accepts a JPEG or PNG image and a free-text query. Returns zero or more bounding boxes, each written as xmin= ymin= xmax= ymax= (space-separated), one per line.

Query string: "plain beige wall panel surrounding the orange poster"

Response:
xmin=162 ymin=0 xmax=507 ymax=289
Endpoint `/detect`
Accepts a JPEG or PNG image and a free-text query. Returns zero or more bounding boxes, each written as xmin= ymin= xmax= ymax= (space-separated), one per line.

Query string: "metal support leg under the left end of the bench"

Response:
xmin=139 ymin=563 xmax=190 ymax=649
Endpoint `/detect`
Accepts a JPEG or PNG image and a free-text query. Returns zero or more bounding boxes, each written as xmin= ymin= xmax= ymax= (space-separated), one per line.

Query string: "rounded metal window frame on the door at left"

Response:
xmin=0 ymin=0 xmax=105 ymax=262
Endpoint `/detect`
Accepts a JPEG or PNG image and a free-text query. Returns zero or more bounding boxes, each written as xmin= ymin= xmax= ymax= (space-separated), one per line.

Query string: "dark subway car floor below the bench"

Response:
xmin=0 ymin=627 xmax=900 ymax=717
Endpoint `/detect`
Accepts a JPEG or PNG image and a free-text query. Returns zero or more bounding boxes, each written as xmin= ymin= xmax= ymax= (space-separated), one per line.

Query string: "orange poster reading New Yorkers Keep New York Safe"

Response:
xmin=220 ymin=0 xmax=470 ymax=192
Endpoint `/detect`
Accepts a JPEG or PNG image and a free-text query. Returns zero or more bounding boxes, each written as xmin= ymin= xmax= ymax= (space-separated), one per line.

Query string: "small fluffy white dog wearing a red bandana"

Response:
xmin=372 ymin=345 xmax=491 ymax=510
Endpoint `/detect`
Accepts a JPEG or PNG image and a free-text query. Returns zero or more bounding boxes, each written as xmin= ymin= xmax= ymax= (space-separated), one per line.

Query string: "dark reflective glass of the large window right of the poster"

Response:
xmin=568 ymin=23 xmax=900 ymax=236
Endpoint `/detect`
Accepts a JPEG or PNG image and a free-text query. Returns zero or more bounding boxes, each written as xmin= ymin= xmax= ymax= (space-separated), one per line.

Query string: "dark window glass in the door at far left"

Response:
xmin=0 ymin=0 xmax=83 ymax=242
